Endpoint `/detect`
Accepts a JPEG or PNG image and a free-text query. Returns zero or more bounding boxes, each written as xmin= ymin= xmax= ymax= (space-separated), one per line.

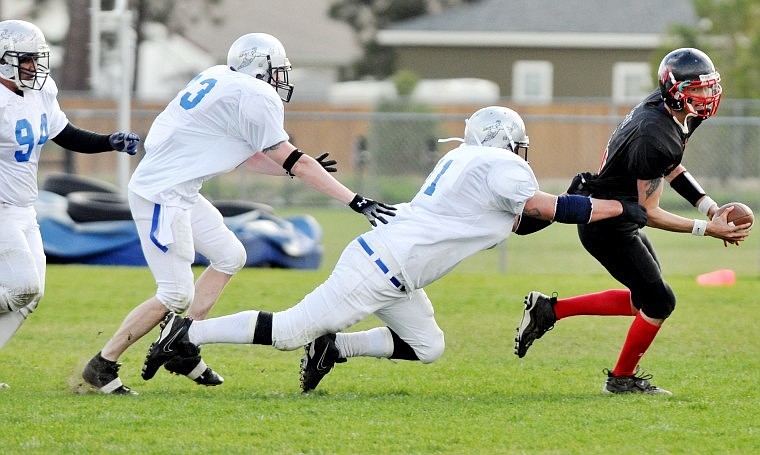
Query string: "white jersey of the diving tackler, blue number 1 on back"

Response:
xmin=362 ymin=145 xmax=538 ymax=289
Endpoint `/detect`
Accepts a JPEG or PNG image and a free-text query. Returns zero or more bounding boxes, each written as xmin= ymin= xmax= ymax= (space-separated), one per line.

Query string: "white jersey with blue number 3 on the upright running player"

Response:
xmin=129 ymin=65 xmax=289 ymax=207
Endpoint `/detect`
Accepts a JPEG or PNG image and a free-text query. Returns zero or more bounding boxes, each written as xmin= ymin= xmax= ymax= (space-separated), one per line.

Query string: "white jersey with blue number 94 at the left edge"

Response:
xmin=0 ymin=76 xmax=69 ymax=207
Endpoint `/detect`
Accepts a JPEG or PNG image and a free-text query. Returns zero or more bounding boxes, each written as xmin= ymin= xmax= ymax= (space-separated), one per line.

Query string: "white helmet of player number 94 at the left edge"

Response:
xmin=0 ymin=20 xmax=50 ymax=90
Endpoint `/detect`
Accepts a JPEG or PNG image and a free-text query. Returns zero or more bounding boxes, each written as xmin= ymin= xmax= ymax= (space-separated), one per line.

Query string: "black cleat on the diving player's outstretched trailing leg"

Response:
xmin=142 ymin=311 xmax=194 ymax=381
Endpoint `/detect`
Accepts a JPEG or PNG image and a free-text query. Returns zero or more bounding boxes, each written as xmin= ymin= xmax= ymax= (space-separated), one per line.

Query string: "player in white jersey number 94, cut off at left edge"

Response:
xmin=0 ymin=20 xmax=140 ymax=390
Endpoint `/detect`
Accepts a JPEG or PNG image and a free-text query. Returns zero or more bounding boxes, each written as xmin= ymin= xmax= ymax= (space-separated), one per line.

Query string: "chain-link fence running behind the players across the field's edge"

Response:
xmin=49 ymin=102 xmax=760 ymax=208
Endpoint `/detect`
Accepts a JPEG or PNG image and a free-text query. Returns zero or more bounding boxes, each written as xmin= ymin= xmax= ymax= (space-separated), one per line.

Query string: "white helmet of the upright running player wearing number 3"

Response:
xmin=227 ymin=33 xmax=293 ymax=103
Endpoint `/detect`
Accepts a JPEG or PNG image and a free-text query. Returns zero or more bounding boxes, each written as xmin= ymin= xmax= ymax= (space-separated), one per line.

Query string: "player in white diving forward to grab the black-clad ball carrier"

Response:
xmin=143 ymin=106 xmax=646 ymax=392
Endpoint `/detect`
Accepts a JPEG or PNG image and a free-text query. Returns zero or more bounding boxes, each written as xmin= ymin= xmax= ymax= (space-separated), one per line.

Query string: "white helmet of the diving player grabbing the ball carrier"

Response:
xmin=464 ymin=106 xmax=530 ymax=161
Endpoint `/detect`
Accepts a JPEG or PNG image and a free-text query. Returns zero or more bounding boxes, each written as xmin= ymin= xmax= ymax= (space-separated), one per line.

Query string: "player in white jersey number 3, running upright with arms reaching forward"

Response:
xmin=82 ymin=33 xmax=395 ymax=394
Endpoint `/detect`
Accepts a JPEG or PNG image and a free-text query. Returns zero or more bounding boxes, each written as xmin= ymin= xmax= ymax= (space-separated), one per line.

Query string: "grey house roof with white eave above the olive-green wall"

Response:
xmin=378 ymin=0 xmax=698 ymax=48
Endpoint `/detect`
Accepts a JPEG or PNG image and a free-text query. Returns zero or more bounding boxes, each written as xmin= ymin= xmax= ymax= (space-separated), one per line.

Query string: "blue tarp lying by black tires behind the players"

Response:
xmin=35 ymin=191 xmax=323 ymax=269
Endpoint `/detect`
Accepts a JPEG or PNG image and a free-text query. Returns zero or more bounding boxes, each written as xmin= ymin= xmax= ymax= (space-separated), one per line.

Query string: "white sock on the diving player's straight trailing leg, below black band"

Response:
xmin=187 ymin=310 xmax=259 ymax=344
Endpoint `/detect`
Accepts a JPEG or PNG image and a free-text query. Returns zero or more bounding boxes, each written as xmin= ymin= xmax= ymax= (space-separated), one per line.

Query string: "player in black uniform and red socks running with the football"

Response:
xmin=515 ymin=48 xmax=749 ymax=395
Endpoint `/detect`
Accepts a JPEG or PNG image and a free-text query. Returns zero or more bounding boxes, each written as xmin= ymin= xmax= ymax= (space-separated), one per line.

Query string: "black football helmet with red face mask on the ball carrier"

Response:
xmin=657 ymin=47 xmax=723 ymax=118
